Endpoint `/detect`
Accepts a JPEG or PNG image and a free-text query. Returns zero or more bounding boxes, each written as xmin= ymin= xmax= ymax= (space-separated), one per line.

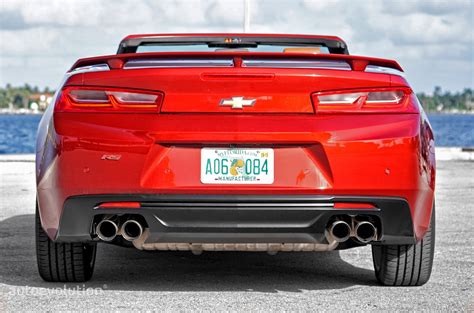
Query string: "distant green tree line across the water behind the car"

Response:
xmin=0 ymin=84 xmax=474 ymax=112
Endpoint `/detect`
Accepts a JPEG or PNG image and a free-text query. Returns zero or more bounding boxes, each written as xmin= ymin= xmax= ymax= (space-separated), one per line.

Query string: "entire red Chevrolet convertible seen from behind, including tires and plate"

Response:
xmin=36 ymin=34 xmax=435 ymax=286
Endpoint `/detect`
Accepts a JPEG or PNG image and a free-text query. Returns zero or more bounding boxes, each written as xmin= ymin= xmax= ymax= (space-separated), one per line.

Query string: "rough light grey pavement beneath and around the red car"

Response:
xmin=0 ymin=156 xmax=474 ymax=312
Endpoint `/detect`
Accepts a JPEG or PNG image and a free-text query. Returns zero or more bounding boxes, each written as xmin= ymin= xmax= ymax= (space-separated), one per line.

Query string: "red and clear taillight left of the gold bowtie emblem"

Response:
xmin=55 ymin=87 xmax=163 ymax=113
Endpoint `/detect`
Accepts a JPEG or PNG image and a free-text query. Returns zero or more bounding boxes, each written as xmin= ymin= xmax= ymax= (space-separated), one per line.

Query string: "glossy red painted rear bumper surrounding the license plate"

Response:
xmin=37 ymin=113 xmax=435 ymax=240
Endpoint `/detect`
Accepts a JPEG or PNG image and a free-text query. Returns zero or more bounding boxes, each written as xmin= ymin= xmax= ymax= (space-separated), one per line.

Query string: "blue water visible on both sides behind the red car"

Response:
xmin=0 ymin=114 xmax=474 ymax=154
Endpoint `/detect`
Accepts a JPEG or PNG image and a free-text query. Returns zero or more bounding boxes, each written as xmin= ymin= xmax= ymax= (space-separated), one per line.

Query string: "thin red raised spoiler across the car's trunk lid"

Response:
xmin=68 ymin=51 xmax=403 ymax=72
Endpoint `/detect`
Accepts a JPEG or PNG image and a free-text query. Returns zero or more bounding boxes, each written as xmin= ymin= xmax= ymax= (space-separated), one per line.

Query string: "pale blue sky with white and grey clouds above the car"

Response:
xmin=0 ymin=0 xmax=474 ymax=93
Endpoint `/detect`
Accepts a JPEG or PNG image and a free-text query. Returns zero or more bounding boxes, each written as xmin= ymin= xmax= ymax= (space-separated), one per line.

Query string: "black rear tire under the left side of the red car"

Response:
xmin=35 ymin=207 xmax=97 ymax=282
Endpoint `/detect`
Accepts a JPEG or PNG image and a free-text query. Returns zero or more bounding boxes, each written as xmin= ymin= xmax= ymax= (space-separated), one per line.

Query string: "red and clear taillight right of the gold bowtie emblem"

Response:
xmin=312 ymin=88 xmax=417 ymax=113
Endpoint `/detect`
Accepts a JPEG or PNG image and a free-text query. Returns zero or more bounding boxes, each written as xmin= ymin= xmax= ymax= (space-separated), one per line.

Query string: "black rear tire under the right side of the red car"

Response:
xmin=372 ymin=205 xmax=436 ymax=286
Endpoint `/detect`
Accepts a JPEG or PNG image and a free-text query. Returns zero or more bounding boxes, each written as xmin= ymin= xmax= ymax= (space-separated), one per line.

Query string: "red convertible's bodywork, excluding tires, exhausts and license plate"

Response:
xmin=36 ymin=34 xmax=435 ymax=282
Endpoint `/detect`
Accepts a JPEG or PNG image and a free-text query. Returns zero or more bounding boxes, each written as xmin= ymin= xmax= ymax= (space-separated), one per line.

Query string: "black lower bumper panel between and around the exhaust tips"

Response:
xmin=56 ymin=195 xmax=415 ymax=244
